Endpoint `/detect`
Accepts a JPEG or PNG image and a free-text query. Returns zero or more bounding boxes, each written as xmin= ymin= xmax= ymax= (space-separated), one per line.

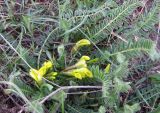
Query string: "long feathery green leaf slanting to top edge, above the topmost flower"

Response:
xmin=91 ymin=0 xmax=141 ymax=42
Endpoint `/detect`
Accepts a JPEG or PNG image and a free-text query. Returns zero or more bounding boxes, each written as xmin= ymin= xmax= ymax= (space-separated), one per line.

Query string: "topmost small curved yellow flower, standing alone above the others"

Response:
xmin=72 ymin=39 xmax=91 ymax=52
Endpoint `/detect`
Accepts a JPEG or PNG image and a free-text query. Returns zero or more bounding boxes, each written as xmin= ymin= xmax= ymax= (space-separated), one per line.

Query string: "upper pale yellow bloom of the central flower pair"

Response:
xmin=75 ymin=56 xmax=90 ymax=68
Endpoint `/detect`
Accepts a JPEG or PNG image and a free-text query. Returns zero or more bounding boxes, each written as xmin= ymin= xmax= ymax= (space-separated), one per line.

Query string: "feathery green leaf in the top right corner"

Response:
xmin=125 ymin=1 xmax=160 ymax=37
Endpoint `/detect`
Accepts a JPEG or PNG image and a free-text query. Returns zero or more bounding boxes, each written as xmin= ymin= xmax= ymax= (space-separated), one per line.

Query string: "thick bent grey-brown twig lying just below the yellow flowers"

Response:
xmin=40 ymin=86 xmax=102 ymax=104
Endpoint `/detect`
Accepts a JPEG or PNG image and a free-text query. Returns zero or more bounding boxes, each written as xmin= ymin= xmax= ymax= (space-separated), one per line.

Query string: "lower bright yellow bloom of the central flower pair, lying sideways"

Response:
xmin=68 ymin=68 xmax=93 ymax=79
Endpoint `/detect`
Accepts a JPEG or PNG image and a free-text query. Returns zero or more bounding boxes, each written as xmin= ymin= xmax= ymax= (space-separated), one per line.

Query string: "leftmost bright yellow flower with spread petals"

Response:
xmin=29 ymin=61 xmax=57 ymax=83
